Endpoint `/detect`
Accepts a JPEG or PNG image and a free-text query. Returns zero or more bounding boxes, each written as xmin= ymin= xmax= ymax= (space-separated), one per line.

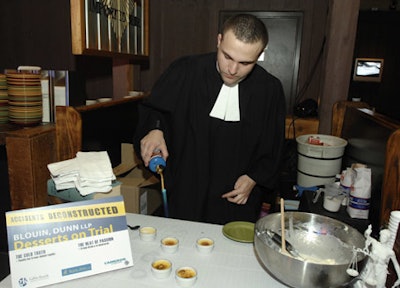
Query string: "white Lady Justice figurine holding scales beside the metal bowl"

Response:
xmin=355 ymin=225 xmax=400 ymax=288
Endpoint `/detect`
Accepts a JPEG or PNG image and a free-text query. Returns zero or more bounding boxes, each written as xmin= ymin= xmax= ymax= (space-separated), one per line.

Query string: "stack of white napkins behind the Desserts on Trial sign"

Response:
xmin=47 ymin=151 xmax=116 ymax=196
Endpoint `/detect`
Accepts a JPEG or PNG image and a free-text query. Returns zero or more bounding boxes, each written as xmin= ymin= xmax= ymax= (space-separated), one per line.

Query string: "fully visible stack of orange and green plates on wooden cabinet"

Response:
xmin=7 ymin=73 xmax=43 ymax=126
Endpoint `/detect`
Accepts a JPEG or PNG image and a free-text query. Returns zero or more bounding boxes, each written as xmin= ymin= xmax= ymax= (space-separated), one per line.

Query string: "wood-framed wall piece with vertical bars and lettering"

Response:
xmin=71 ymin=0 xmax=149 ymax=61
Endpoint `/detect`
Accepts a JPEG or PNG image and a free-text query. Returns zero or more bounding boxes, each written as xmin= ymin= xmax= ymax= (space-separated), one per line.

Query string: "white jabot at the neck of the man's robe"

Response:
xmin=209 ymin=84 xmax=240 ymax=121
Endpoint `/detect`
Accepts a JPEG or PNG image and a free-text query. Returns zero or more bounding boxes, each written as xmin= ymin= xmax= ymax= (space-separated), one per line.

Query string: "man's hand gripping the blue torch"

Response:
xmin=140 ymin=129 xmax=169 ymax=167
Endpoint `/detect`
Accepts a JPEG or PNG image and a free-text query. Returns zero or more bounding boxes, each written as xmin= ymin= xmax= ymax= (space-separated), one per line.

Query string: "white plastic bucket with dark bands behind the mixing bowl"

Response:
xmin=296 ymin=134 xmax=347 ymax=187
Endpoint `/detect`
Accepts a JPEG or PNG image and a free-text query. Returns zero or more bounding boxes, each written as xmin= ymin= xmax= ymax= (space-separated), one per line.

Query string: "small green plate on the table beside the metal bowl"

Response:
xmin=222 ymin=221 xmax=254 ymax=243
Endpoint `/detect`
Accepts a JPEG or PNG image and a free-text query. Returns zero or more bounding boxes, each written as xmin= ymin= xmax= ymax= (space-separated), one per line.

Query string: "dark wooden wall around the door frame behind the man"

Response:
xmin=141 ymin=0 xmax=329 ymax=109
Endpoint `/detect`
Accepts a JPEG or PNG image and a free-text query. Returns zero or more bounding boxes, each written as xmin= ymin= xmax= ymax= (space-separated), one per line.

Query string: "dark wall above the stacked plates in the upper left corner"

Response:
xmin=0 ymin=0 xmax=75 ymax=70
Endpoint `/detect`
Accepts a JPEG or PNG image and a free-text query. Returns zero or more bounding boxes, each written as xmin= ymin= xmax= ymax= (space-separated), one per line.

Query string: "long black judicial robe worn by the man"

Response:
xmin=134 ymin=53 xmax=286 ymax=224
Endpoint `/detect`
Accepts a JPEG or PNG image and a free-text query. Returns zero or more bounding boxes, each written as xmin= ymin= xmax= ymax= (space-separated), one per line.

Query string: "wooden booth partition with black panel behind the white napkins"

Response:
xmin=56 ymin=96 xmax=145 ymax=163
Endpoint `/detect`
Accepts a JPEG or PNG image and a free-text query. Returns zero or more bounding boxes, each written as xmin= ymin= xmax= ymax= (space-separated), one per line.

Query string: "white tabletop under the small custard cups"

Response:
xmin=0 ymin=213 xmax=286 ymax=288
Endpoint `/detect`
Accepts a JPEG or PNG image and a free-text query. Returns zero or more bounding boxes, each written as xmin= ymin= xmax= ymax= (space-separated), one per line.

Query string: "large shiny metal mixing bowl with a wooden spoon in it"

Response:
xmin=254 ymin=212 xmax=367 ymax=288
